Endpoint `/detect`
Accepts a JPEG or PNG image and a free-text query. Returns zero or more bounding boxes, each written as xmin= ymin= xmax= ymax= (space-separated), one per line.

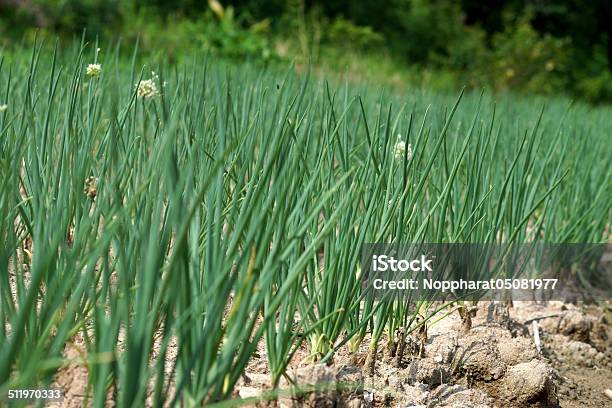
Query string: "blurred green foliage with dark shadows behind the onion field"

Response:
xmin=0 ymin=0 xmax=612 ymax=102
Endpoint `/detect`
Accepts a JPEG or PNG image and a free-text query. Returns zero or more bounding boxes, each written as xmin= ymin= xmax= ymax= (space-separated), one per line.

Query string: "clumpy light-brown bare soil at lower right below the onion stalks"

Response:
xmin=237 ymin=302 xmax=612 ymax=408
